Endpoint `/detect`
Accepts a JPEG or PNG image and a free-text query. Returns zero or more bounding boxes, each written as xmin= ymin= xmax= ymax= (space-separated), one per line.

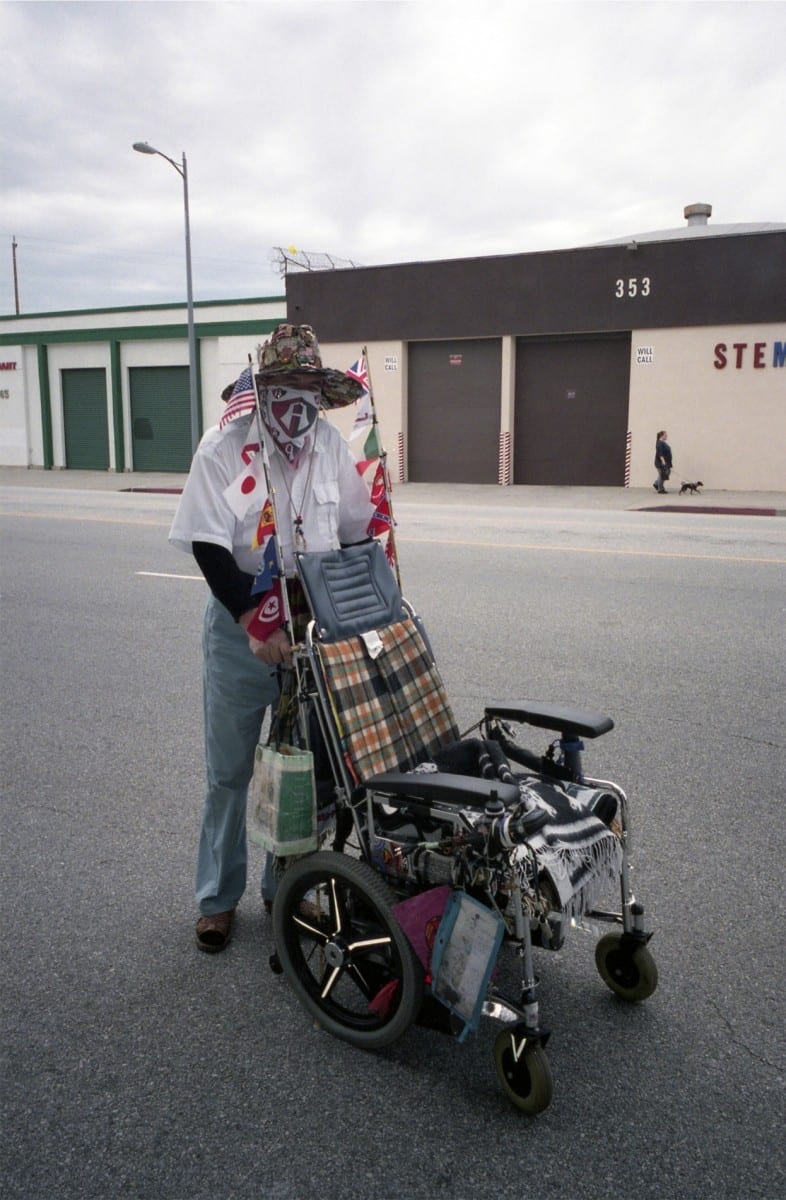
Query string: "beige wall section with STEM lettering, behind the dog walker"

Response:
xmin=629 ymin=325 xmax=786 ymax=491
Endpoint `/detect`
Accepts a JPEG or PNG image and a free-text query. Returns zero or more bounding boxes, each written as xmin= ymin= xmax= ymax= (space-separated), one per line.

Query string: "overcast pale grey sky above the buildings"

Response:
xmin=0 ymin=0 xmax=786 ymax=314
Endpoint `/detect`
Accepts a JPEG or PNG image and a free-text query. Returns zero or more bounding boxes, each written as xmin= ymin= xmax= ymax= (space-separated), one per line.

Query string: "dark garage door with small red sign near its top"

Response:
xmin=407 ymin=338 xmax=502 ymax=484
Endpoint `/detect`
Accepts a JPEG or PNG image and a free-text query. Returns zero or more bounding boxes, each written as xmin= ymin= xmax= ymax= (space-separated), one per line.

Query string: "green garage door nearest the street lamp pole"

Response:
xmin=128 ymin=367 xmax=191 ymax=470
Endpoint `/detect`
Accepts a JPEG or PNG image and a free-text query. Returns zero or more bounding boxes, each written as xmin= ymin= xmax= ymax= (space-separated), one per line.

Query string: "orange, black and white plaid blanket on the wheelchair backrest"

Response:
xmin=317 ymin=618 xmax=458 ymax=781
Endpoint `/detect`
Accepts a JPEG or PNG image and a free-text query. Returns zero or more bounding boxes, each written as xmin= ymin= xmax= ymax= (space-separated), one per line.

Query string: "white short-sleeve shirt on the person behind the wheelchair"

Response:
xmin=169 ymin=416 xmax=373 ymax=575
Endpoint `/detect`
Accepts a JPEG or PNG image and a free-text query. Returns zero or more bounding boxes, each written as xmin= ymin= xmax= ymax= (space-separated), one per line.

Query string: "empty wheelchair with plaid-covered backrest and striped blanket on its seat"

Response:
xmin=262 ymin=542 xmax=658 ymax=1115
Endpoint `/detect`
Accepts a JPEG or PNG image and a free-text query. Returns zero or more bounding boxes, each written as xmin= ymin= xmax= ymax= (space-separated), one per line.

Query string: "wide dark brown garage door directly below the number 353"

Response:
xmin=514 ymin=334 xmax=630 ymax=486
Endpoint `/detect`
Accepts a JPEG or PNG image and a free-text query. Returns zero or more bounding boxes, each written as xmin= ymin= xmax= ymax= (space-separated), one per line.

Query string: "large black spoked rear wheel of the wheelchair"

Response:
xmin=272 ymin=851 xmax=424 ymax=1050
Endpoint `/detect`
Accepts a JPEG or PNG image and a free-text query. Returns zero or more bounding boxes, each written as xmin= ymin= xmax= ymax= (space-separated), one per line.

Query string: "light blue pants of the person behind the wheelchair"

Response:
xmin=196 ymin=595 xmax=278 ymax=916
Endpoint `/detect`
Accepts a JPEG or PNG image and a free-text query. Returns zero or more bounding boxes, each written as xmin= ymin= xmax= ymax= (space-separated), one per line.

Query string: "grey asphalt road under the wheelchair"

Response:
xmin=0 ymin=487 xmax=786 ymax=1200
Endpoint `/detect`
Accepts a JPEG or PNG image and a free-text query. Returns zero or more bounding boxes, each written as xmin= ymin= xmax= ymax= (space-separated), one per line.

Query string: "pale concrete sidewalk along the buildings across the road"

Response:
xmin=0 ymin=467 xmax=786 ymax=516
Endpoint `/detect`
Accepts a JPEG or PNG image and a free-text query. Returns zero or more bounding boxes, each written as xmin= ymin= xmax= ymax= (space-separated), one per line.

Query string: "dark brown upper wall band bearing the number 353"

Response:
xmin=287 ymin=232 xmax=786 ymax=342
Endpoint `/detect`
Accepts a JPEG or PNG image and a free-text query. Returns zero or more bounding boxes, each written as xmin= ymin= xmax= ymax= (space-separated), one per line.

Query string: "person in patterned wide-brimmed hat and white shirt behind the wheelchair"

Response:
xmin=169 ymin=324 xmax=373 ymax=953
